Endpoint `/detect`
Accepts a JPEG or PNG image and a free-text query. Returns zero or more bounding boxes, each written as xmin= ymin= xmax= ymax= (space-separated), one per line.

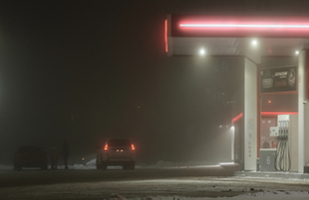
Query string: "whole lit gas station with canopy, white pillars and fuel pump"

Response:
xmin=165 ymin=14 xmax=309 ymax=173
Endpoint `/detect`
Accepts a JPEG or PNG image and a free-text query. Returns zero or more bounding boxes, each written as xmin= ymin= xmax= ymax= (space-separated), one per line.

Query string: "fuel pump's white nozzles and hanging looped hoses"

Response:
xmin=274 ymin=115 xmax=291 ymax=171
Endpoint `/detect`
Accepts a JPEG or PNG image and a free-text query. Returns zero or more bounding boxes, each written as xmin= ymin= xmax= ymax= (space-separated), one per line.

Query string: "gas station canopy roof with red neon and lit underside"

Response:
xmin=166 ymin=15 xmax=309 ymax=58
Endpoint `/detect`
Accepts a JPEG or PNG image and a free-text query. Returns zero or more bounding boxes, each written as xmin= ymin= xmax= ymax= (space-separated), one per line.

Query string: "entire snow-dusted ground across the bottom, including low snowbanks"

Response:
xmin=0 ymin=161 xmax=309 ymax=200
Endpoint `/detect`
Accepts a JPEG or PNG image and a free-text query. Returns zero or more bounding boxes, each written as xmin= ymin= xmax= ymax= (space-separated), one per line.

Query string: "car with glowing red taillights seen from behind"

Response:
xmin=96 ymin=138 xmax=135 ymax=169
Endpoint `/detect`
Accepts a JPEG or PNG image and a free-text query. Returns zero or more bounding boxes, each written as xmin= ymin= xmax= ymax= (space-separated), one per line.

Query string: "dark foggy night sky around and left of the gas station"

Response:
xmin=0 ymin=0 xmax=309 ymax=162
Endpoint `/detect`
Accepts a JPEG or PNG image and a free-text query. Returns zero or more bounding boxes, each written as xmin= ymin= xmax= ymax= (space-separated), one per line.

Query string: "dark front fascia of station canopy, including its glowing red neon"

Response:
xmin=171 ymin=15 xmax=309 ymax=38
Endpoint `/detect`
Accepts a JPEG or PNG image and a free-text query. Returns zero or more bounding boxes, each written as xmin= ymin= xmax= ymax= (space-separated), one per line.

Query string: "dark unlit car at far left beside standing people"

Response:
xmin=14 ymin=146 xmax=48 ymax=170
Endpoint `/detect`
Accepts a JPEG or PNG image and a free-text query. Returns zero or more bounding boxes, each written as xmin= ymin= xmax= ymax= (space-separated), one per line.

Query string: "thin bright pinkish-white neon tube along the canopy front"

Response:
xmin=180 ymin=24 xmax=309 ymax=29
